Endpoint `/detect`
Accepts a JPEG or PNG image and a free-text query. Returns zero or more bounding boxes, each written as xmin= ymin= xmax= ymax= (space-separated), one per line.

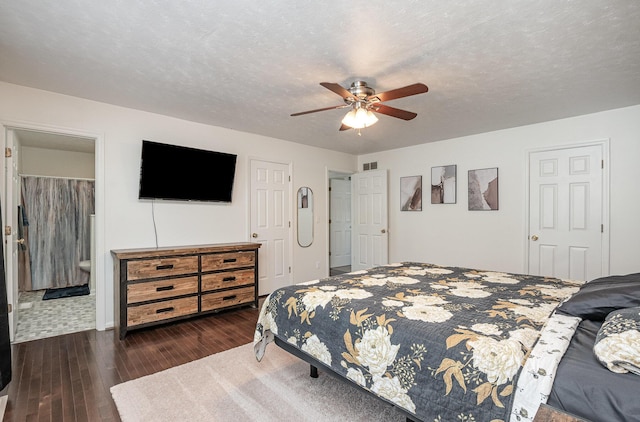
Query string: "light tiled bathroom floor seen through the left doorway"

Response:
xmin=13 ymin=290 xmax=96 ymax=343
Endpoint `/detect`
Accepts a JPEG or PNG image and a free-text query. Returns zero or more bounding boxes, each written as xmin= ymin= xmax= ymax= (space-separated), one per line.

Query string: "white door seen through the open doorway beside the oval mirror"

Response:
xmin=329 ymin=179 xmax=351 ymax=268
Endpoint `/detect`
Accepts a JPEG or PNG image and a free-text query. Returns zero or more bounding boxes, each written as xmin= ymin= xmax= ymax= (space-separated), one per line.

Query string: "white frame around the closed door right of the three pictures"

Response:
xmin=522 ymin=138 xmax=611 ymax=276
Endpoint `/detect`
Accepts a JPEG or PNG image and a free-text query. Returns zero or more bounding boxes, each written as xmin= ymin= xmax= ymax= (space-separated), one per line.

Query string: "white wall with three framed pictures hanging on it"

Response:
xmin=358 ymin=106 xmax=640 ymax=274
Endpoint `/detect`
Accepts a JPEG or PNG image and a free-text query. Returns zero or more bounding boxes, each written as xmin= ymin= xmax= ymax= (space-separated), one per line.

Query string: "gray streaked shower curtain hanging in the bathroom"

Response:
xmin=22 ymin=176 xmax=95 ymax=290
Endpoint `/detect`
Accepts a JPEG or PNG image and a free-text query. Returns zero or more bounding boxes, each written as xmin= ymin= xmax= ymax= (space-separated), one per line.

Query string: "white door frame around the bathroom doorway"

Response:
xmin=0 ymin=120 xmax=107 ymax=339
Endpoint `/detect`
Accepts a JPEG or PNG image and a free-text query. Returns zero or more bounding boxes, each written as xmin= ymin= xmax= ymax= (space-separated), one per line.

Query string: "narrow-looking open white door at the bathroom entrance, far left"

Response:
xmin=2 ymin=130 xmax=20 ymax=341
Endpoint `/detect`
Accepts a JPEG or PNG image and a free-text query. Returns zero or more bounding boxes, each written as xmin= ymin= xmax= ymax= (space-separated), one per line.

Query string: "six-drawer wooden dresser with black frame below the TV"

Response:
xmin=111 ymin=243 xmax=260 ymax=339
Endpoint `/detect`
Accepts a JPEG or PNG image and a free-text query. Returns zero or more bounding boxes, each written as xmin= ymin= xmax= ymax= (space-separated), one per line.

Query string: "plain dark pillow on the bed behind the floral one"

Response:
xmin=558 ymin=273 xmax=640 ymax=321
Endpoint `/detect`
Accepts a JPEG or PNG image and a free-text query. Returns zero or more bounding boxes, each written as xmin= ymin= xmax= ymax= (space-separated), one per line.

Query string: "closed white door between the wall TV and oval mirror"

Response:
xmin=250 ymin=160 xmax=291 ymax=296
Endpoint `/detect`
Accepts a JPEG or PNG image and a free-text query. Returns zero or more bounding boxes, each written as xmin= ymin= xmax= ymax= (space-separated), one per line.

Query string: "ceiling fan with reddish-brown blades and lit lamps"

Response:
xmin=291 ymin=81 xmax=429 ymax=130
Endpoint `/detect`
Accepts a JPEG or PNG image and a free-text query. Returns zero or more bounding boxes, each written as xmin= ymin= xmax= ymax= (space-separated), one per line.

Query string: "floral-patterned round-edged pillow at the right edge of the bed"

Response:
xmin=593 ymin=307 xmax=640 ymax=375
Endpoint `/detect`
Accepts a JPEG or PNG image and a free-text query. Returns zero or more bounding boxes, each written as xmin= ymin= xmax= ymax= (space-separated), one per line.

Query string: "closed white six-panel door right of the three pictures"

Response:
xmin=529 ymin=145 xmax=606 ymax=280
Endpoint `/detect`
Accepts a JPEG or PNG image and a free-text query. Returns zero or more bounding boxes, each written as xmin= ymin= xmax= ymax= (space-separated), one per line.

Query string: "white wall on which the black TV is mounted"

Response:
xmin=0 ymin=82 xmax=356 ymax=326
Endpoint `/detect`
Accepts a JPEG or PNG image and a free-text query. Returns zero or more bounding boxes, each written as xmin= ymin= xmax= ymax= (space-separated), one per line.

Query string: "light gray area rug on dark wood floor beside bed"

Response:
xmin=111 ymin=344 xmax=405 ymax=422
